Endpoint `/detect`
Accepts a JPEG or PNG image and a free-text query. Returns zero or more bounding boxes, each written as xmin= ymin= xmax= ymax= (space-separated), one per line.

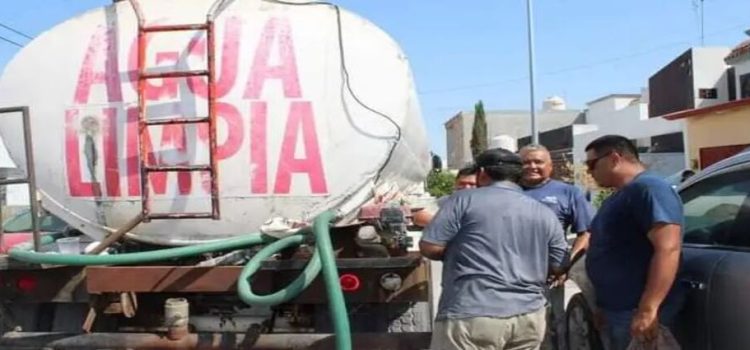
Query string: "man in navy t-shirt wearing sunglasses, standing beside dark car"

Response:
xmin=586 ymin=135 xmax=684 ymax=350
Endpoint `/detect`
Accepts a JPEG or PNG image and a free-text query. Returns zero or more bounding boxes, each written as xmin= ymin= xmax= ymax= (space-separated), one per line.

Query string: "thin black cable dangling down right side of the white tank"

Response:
xmin=264 ymin=0 xmax=402 ymax=183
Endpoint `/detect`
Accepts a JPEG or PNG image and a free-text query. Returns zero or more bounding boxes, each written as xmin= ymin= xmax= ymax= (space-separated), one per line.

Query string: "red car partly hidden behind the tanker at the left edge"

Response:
xmin=0 ymin=208 xmax=68 ymax=254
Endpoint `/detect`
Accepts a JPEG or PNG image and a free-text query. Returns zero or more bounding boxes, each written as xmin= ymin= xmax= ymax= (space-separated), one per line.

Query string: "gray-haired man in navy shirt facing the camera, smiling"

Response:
xmin=519 ymin=145 xmax=594 ymax=349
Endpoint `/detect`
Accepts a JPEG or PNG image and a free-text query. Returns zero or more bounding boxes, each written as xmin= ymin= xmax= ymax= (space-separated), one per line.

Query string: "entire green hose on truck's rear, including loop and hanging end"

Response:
xmin=9 ymin=211 xmax=352 ymax=350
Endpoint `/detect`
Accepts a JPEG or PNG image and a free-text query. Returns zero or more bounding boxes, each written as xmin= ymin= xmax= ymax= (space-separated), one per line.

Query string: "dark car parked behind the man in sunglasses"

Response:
xmin=567 ymin=151 xmax=750 ymax=350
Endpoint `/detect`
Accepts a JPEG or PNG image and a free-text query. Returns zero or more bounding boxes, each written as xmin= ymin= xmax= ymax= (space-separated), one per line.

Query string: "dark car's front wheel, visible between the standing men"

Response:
xmin=565 ymin=293 xmax=604 ymax=350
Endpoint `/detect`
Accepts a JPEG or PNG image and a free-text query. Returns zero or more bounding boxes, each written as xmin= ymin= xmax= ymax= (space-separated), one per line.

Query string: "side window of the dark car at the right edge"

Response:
xmin=680 ymin=170 xmax=750 ymax=247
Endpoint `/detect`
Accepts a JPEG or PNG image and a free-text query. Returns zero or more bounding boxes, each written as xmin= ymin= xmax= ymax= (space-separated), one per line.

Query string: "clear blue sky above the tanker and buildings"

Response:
xmin=0 ymin=0 xmax=750 ymax=159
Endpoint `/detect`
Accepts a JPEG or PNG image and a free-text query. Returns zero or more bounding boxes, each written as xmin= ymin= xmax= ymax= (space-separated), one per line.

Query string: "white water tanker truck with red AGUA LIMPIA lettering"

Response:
xmin=0 ymin=0 xmax=431 ymax=349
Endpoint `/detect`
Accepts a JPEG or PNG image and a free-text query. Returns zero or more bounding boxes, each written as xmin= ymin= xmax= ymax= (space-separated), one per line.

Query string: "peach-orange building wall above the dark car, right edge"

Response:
xmin=686 ymin=106 xmax=750 ymax=164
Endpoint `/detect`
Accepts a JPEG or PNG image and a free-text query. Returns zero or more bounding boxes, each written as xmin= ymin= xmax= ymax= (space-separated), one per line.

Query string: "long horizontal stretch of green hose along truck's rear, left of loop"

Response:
xmin=9 ymin=233 xmax=274 ymax=266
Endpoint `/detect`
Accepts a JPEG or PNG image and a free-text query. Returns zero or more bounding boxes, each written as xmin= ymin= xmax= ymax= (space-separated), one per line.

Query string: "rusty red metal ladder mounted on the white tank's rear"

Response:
xmin=128 ymin=0 xmax=224 ymax=222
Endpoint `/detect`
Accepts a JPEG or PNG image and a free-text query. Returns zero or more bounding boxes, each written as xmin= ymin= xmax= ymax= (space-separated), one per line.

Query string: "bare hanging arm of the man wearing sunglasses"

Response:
xmin=631 ymin=223 xmax=682 ymax=340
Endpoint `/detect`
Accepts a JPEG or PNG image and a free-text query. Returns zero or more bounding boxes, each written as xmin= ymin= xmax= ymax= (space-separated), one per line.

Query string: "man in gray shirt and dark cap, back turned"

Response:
xmin=419 ymin=149 xmax=567 ymax=350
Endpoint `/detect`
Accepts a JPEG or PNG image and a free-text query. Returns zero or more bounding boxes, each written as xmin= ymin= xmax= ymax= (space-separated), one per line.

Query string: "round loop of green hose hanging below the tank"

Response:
xmin=237 ymin=234 xmax=320 ymax=306
